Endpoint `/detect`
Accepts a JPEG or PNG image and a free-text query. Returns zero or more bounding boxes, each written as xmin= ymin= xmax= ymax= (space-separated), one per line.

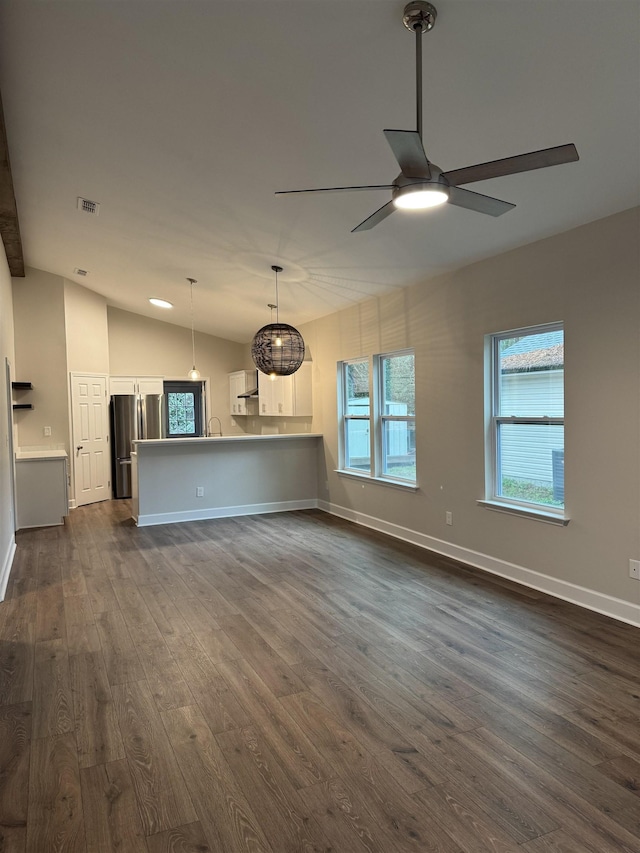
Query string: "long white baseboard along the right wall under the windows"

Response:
xmin=318 ymin=501 xmax=640 ymax=627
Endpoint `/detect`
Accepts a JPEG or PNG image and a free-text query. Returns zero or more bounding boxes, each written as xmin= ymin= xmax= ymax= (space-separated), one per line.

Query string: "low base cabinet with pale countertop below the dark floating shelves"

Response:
xmin=16 ymin=450 xmax=69 ymax=530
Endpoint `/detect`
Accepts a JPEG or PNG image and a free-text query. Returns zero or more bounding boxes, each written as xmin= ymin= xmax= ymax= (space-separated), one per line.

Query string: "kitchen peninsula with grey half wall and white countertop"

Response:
xmin=131 ymin=433 xmax=322 ymax=527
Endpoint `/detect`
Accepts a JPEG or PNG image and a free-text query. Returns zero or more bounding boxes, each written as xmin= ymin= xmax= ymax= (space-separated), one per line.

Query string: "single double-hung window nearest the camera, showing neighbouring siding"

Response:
xmin=487 ymin=323 xmax=564 ymax=515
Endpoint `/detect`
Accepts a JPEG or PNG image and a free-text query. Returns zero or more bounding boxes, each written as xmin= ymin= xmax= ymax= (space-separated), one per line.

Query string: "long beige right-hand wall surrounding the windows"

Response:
xmin=300 ymin=208 xmax=640 ymax=618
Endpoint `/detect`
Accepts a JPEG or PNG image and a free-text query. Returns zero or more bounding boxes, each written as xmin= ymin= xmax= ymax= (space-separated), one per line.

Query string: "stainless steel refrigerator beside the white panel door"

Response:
xmin=111 ymin=394 xmax=165 ymax=498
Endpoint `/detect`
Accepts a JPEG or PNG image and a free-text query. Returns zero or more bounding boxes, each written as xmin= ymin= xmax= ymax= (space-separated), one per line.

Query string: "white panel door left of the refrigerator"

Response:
xmin=71 ymin=374 xmax=111 ymax=506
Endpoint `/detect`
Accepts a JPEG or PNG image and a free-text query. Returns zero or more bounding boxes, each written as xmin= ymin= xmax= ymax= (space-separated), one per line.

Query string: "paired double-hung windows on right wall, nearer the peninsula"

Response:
xmin=339 ymin=351 xmax=416 ymax=484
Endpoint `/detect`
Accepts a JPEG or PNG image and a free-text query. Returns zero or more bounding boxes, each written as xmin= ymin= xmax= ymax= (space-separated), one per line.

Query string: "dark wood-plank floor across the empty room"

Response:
xmin=0 ymin=501 xmax=640 ymax=853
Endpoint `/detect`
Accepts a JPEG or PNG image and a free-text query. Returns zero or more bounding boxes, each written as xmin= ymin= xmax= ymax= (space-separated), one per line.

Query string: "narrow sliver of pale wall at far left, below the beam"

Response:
xmin=0 ymin=249 xmax=15 ymax=600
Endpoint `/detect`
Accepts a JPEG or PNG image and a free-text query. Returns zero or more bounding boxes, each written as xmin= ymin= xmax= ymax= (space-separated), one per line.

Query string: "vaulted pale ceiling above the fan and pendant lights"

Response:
xmin=0 ymin=0 xmax=640 ymax=342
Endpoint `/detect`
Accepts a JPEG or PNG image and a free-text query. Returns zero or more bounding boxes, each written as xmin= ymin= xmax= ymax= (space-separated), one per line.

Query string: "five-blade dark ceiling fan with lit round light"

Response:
xmin=276 ymin=0 xmax=579 ymax=233
